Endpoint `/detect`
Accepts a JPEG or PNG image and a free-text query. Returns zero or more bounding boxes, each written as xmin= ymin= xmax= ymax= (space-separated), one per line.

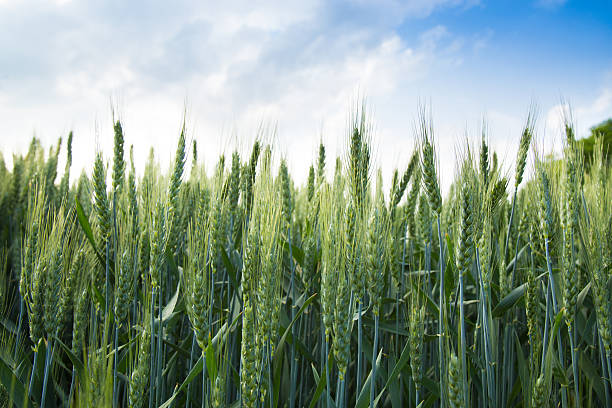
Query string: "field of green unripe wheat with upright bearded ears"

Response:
xmin=0 ymin=108 xmax=612 ymax=408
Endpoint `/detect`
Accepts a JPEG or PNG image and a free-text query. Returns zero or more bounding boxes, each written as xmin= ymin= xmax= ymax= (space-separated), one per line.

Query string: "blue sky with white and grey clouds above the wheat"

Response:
xmin=0 ymin=0 xmax=612 ymax=192
